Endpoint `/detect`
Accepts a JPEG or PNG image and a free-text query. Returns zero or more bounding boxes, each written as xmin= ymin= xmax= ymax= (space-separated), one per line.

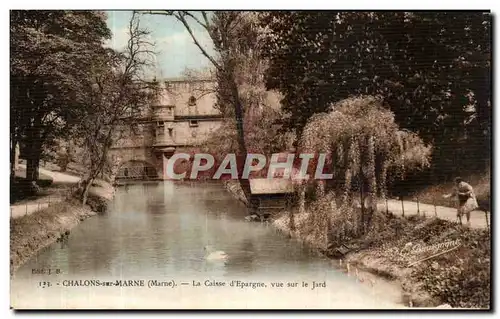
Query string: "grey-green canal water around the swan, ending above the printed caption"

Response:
xmin=14 ymin=182 xmax=402 ymax=305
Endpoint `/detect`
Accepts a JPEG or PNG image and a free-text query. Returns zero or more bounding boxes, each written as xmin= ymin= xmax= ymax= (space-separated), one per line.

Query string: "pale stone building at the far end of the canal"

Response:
xmin=112 ymin=78 xmax=222 ymax=179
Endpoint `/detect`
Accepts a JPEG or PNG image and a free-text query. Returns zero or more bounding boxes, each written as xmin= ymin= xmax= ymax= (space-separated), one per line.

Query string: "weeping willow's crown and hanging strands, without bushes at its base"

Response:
xmin=299 ymin=96 xmax=430 ymax=236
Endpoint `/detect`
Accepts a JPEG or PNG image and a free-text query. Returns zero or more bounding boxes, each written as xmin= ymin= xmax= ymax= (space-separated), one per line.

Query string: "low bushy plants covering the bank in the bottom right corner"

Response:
xmin=320 ymin=214 xmax=491 ymax=308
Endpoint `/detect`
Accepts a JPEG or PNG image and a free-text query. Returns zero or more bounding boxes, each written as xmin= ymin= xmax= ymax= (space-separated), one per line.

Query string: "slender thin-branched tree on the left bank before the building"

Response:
xmin=76 ymin=13 xmax=157 ymax=204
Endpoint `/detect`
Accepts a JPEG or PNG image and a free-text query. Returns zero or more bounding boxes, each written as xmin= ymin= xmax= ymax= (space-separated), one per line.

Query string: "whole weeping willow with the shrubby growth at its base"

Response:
xmin=297 ymin=96 xmax=431 ymax=249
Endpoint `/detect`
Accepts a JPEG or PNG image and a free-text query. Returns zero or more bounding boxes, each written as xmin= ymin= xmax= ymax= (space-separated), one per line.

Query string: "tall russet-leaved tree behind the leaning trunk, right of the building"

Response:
xmin=193 ymin=12 xmax=292 ymax=160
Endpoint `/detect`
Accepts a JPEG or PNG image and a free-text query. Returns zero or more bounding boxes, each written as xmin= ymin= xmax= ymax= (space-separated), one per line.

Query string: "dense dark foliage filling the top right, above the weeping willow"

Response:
xmin=261 ymin=11 xmax=491 ymax=179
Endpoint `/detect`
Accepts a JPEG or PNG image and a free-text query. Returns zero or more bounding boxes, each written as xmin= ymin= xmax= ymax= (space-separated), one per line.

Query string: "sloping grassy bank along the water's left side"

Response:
xmin=10 ymin=185 xmax=113 ymax=276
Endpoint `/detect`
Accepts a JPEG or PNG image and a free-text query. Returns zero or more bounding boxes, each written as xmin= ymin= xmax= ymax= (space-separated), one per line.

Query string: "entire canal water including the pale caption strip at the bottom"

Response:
xmin=11 ymin=182 xmax=401 ymax=309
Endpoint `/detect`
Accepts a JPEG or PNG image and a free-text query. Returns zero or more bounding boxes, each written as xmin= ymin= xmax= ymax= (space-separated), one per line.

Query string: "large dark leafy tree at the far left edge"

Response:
xmin=10 ymin=10 xmax=111 ymax=181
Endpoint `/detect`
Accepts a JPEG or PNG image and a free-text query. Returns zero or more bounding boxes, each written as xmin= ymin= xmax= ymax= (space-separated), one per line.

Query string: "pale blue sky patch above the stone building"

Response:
xmin=107 ymin=11 xmax=213 ymax=78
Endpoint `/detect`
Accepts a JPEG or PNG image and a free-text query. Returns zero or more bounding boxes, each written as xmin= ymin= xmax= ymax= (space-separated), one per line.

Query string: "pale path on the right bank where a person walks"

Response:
xmin=378 ymin=199 xmax=490 ymax=228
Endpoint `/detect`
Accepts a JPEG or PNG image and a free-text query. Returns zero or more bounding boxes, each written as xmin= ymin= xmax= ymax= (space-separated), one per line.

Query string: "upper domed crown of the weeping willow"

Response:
xmin=299 ymin=96 xmax=430 ymax=191
